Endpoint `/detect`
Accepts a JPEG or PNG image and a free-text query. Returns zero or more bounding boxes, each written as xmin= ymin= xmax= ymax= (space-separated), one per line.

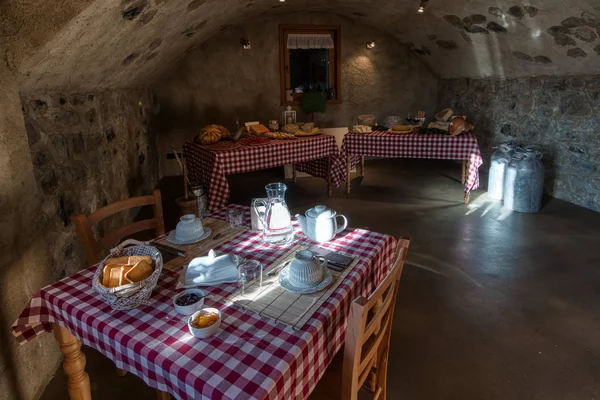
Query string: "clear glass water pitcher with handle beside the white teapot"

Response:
xmin=252 ymin=183 xmax=294 ymax=245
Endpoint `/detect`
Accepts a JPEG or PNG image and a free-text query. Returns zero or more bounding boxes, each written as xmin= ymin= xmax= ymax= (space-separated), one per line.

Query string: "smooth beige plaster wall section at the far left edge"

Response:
xmin=0 ymin=51 xmax=59 ymax=400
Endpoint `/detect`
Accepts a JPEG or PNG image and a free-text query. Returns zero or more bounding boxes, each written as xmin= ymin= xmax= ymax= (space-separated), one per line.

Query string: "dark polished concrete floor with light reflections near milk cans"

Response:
xmin=42 ymin=160 xmax=600 ymax=400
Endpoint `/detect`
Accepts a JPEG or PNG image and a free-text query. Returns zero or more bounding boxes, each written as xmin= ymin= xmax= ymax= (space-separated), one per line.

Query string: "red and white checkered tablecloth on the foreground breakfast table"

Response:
xmin=12 ymin=206 xmax=396 ymax=399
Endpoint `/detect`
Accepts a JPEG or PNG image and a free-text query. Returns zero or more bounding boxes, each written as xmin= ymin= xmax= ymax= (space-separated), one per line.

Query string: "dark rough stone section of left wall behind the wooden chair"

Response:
xmin=22 ymin=89 xmax=159 ymax=278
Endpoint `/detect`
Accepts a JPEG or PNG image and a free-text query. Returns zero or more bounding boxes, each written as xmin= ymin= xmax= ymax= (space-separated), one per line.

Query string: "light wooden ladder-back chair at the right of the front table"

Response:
xmin=310 ymin=238 xmax=410 ymax=400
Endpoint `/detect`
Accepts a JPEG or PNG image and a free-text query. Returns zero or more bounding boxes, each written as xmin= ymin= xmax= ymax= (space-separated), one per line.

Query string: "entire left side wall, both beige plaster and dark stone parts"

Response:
xmin=0 ymin=89 xmax=158 ymax=399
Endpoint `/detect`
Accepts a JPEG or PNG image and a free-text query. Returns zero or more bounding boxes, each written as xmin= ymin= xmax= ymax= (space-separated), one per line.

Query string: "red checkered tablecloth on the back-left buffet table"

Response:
xmin=183 ymin=135 xmax=339 ymax=210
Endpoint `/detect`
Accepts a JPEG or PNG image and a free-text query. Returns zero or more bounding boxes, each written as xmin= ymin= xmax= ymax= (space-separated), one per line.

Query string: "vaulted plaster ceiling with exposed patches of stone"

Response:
xmin=0 ymin=0 xmax=600 ymax=91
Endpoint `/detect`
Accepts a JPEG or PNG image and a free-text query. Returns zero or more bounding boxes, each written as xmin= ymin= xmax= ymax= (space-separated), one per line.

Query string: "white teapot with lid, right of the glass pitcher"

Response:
xmin=296 ymin=205 xmax=348 ymax=242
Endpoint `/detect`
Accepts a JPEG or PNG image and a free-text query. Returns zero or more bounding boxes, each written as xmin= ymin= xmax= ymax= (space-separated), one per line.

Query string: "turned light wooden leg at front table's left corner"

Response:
xmin=53 ymin=324 xmax=92 ymax=400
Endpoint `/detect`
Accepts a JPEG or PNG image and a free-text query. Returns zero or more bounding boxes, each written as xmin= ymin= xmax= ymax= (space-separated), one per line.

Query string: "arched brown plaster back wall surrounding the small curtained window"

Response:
xmin=155 ymin=13 xmax=437 ymax=174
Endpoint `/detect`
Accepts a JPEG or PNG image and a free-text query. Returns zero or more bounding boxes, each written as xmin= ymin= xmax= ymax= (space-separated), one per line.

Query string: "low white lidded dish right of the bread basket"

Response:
xmin=177 ymin=250 xmax=239 ymax=288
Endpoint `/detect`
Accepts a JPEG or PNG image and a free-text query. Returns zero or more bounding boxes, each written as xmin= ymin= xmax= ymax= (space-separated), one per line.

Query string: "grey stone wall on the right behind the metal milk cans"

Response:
xmin=438 ymin=75 xmax=600 ymax=211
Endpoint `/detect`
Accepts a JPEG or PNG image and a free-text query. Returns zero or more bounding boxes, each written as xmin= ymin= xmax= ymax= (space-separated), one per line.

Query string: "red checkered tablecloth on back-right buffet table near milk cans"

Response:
xmin=332 ymin=132 xmax=483 ymax=193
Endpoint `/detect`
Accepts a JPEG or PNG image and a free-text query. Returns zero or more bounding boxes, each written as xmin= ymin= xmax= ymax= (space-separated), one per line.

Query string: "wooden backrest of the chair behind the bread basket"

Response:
xmin=71 ymin=189 xmax=165 ymax=265
